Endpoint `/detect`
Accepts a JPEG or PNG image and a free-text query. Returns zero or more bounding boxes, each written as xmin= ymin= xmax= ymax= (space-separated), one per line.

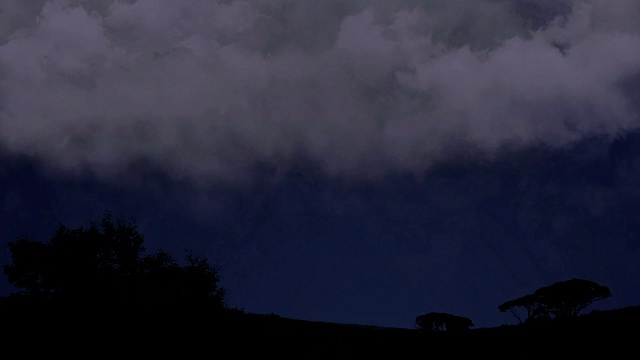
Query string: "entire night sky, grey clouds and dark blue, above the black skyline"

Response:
xmin=0 ymin=0 xmax=640 ymax=328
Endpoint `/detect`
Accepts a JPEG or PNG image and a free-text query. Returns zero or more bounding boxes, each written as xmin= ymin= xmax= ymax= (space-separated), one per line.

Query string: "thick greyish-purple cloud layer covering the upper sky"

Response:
xmin=0 ymin=0 xmax=640 ymax=184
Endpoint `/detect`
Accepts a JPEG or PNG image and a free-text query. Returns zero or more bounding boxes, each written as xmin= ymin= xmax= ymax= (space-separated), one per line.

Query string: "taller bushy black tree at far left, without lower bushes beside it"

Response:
xmin=3 ymin=213 xmax=144 ymax=300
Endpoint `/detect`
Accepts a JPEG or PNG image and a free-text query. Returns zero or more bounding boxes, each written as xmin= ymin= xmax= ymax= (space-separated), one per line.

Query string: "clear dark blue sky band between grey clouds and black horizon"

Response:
xmin=0 ymin=131 xmax=640 ymax=327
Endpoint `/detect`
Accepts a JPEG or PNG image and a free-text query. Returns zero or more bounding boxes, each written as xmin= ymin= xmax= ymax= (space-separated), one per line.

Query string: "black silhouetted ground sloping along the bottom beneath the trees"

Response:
xmin=0 ymin=300 xmax=640 ymax=359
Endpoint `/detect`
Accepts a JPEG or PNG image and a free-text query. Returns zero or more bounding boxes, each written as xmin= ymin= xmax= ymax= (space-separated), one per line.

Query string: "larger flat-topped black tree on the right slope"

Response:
xmin=498 ymin=278 xmax=611 ymax=323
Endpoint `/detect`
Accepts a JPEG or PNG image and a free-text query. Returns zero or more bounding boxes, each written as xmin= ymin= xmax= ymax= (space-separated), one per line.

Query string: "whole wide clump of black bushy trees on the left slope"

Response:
xmin=3 ymin=213 xmax=225 ymax=308
